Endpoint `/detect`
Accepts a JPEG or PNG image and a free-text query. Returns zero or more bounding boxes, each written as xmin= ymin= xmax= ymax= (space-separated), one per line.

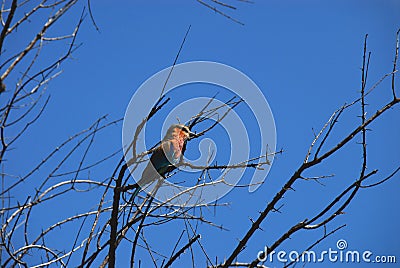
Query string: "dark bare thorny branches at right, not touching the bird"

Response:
xmin=218 ymin=33 xmax=400 ymax=267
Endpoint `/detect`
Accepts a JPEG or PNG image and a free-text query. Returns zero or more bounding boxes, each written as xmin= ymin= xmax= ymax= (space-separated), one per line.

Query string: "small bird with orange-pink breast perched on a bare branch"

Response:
xmin=132 ymin=124 xmax=196 ymax=198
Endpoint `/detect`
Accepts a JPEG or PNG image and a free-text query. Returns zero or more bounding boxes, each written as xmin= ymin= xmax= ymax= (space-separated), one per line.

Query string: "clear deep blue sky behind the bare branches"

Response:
xmin=6 ymin=0 xmax=400 ymax=267
